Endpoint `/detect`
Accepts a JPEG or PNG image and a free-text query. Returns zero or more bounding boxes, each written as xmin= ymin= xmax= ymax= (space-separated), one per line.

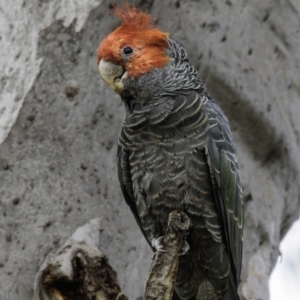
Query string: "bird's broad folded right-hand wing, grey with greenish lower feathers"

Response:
xmin=205 ymin=101 xmax=243 ymax=286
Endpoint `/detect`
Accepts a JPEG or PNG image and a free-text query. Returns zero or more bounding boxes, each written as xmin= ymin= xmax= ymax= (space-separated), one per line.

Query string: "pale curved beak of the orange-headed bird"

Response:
xmin=99 ymin=59 xmax=127 ymax=94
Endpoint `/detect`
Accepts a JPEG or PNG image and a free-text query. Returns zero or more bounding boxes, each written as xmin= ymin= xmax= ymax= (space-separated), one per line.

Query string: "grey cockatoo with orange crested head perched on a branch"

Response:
xmin=97 ymin=3 xmax=244 ymax=300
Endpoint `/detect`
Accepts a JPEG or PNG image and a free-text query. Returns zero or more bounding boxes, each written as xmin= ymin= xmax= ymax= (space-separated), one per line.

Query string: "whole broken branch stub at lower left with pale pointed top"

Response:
xmin=33 ymin=218 xmax=121 ymax=300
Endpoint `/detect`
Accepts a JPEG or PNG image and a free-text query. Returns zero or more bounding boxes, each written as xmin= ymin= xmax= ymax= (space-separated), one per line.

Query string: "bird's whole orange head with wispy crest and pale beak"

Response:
xmin=97 ymin=4 xmax=170 ymax=93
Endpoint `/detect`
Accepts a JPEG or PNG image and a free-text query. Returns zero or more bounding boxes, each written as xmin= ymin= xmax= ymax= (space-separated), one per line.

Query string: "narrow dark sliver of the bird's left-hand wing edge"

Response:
xmin=117 ymin=145 xmax=153 ymax=249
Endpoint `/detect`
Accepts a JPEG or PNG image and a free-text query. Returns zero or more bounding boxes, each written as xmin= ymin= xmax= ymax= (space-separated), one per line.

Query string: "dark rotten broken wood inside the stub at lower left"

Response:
xmin=41 ymin=249 xmax=120 ymax=300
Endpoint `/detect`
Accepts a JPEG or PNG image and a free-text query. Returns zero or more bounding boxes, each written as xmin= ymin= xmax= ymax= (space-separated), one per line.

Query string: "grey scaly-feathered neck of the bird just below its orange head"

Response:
xmin=121 ymin=40 xmax=205 ymax=112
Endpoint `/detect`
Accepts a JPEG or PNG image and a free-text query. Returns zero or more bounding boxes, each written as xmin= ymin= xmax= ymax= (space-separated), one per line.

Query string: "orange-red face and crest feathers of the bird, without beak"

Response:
xmin=97 ymin=3 xmax=170 ymax=77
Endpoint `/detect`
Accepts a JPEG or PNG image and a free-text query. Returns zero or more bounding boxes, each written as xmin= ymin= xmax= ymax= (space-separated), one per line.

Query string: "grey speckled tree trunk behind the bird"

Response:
xmin=0 ymin=0 xmax=300 ymax=300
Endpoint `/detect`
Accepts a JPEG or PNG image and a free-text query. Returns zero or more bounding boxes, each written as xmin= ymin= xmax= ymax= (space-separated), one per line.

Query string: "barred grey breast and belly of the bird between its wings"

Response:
xmin=119 ymin=93 xmax=221 ymax=241
